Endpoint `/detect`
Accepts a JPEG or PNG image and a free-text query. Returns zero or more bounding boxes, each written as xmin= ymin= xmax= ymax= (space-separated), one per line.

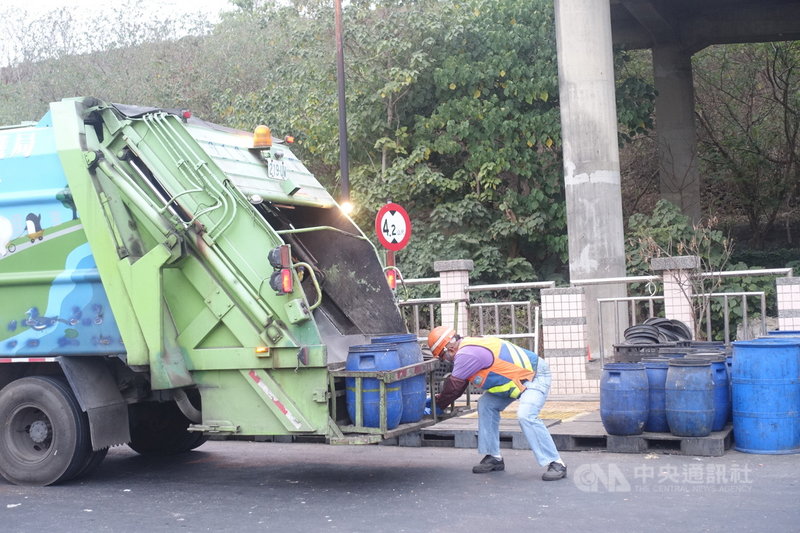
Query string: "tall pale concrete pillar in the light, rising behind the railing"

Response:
xmin=555 ymin=0 xmax=627 ymax=353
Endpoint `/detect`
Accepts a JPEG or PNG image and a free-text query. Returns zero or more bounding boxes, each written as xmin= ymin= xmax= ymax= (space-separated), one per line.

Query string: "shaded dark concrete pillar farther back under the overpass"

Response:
xmin=653 ymin=44 xmax=701 ymax=223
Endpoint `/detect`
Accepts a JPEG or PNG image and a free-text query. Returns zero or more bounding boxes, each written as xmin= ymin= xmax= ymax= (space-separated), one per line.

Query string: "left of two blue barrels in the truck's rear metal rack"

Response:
xmin=345 ymin=344 xmax=403 ymax=429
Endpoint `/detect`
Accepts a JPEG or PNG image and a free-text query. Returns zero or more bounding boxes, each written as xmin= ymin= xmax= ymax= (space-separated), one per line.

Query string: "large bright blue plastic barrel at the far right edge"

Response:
xmin=731 ymin=337 xmax=800 ymax=454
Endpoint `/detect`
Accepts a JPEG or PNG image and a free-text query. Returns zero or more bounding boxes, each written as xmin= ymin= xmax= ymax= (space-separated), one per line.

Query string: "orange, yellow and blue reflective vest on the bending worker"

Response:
xmin=459 ymin=337 xmax=539 ymax=398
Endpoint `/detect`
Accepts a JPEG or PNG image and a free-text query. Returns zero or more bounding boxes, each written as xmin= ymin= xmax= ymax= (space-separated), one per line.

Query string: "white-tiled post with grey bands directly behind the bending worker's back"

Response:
xmin=542 ymin=287 xmax=599 ymax=397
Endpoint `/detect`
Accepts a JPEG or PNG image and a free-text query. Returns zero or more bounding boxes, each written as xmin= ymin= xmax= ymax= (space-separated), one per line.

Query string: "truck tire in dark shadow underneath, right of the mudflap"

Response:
xmin=128 ymin=402 xmax=207 ymax=455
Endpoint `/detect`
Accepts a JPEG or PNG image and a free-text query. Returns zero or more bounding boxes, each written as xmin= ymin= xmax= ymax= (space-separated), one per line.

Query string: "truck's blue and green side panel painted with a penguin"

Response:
xmin=0 ymin=115 xmax=124 ymax=357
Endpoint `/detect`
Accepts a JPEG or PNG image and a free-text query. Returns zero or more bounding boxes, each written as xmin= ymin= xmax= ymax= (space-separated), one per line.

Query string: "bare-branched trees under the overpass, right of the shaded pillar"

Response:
xmin=695 ymin=42 xmax=800 ymax=248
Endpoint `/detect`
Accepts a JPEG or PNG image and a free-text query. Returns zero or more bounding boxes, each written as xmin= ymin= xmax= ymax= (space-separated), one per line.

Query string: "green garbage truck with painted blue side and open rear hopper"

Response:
xmin=0 ymin=98 xmax=436 ymax=485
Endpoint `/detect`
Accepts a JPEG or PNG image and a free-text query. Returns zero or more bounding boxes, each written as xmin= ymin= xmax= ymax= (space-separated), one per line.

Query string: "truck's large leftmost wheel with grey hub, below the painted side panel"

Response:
xmin=0 ymin=376 xmax=91 ymax=485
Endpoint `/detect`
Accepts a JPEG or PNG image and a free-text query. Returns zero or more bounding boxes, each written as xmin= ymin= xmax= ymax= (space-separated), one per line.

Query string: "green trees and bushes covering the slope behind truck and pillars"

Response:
xmin=0 ymin=0 xmax=800 ymax=283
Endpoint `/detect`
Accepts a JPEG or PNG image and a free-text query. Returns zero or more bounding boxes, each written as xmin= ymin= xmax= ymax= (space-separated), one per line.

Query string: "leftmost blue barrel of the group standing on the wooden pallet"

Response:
xmin=600 ymin=363 xmax=649 ymax=435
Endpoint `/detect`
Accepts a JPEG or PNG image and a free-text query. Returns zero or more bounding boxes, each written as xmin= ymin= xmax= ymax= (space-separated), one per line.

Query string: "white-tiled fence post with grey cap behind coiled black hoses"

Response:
xmin=650 ymin=255 xmax=700 ymax=338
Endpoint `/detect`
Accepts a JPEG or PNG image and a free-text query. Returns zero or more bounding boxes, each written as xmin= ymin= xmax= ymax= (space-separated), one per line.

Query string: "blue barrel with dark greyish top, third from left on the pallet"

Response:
xmin=664 ymin=357 xmax=714 ymax=437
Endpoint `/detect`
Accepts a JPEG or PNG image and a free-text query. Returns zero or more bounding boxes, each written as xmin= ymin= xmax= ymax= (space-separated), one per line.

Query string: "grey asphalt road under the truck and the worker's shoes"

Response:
xmin=0 ymin=441 xmax=800 ymax=533
